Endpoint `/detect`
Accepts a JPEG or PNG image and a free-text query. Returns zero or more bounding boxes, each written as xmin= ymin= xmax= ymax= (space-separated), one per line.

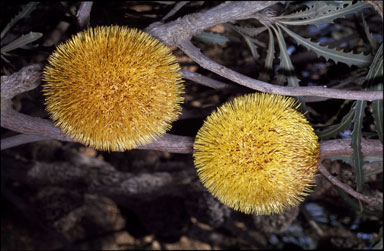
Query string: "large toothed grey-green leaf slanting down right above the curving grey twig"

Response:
xmin=278 ymin=22 xmax=372 ymax=67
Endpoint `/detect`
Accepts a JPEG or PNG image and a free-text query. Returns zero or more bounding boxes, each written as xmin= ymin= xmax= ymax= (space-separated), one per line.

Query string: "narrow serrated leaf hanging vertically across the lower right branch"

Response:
xmin=352 ymin=100 xmax=367 ymax=192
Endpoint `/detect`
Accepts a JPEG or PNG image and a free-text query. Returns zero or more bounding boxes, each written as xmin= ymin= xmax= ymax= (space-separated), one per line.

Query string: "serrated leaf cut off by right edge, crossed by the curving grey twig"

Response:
xmin=366 ymin=44 xmax=383 ymax=143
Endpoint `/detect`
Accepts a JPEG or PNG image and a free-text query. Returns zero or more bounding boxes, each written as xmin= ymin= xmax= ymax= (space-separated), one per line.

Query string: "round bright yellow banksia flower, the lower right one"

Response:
xmin=193 ymin=93 xmax=320 ymax=215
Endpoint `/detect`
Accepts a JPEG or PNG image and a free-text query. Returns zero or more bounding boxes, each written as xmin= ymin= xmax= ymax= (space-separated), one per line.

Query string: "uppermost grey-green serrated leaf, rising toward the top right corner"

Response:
xmin=279 ymin=2 xmax=371 ymax=26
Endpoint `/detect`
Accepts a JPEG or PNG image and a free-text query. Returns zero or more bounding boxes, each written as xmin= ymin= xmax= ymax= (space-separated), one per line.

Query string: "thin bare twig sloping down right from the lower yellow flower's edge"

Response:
xmin=319 ymin=164 xmax=383 ymax=206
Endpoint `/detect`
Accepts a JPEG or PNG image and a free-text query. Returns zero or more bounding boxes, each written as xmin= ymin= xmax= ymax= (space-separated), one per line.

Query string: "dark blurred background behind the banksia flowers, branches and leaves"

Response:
xmin=1 ymin=1 xmax=383 ymax=250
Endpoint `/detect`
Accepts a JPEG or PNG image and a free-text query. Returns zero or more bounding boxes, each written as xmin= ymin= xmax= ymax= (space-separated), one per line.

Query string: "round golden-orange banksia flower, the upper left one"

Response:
xmin=43 ymin=26 xmax=184 ymax=151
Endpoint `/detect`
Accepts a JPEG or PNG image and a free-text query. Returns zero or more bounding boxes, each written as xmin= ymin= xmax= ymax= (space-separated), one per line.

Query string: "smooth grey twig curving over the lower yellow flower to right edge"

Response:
xmin=178 ymin=40 xmax=383 ymax=101
